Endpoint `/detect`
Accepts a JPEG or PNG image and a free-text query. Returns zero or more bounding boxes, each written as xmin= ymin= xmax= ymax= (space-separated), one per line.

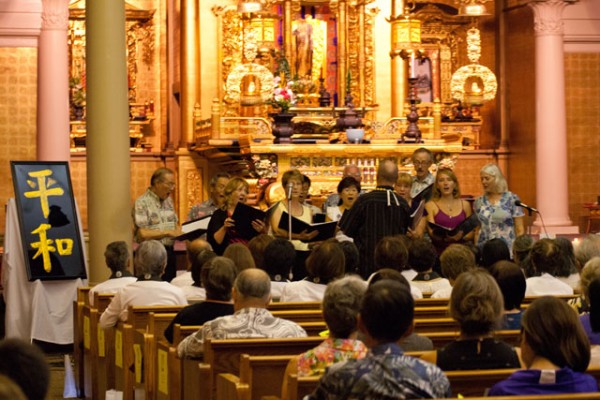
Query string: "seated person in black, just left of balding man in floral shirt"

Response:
xmin=165 ymin=253 xmax=237 ymax=343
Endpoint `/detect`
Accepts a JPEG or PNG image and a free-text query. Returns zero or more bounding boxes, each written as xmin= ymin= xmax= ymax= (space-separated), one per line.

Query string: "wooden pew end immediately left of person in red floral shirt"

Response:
xmin=216 ymin=354 xmax=296 ymax=400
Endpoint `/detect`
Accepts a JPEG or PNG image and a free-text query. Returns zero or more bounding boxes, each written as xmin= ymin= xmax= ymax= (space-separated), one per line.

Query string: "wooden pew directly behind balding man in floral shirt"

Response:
xmin=182 ymin=337 xmax=323 ymax=400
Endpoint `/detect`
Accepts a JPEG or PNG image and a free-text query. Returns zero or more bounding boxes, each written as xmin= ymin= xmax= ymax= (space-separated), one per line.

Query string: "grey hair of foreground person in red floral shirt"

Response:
xmin=323 ymin=276 xmax=367 ymax=339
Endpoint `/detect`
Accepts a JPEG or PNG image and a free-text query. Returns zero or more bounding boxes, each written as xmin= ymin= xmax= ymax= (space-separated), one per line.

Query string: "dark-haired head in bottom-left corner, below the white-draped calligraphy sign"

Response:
xmin=0 ymin=338 xmax=50 ymax=400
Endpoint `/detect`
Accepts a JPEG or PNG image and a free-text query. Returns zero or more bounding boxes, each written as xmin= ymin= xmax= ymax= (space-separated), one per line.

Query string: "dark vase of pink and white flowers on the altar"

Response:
xmin=269 ymin=77 xmax=296 ymax=143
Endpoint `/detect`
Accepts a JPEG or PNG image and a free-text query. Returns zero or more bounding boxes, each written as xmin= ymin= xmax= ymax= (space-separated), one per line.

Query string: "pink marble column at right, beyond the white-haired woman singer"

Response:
xmin=529 ymin=0 xmax=578 ymax=234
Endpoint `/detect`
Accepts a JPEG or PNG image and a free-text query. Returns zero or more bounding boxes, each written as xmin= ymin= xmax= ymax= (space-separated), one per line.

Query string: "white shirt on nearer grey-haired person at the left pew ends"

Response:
xmin=100 ymin=281 xmax=187 ymax=329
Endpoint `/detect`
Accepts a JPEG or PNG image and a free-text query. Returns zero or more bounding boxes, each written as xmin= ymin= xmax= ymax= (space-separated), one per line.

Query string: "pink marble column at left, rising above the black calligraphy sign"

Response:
xmin=37 ymin=0 xmax=70 ymax=161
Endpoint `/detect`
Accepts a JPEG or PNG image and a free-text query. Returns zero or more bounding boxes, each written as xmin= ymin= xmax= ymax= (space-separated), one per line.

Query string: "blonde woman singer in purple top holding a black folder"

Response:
xmin=425 ymin=168 xmax=473 ymax=254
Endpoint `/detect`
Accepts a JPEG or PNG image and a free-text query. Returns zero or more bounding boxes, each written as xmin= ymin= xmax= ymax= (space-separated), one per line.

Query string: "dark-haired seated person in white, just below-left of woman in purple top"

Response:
xmin=408 ymin=238 xmax=451 ymax=295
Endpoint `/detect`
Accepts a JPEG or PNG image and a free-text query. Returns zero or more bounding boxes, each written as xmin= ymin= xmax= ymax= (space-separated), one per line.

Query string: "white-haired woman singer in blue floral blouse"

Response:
xmin=474 ymin=164 xmax=525 ymax=252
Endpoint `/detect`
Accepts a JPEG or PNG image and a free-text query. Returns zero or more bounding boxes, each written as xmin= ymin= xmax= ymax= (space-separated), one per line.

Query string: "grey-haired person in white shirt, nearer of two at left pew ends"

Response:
xmin=100 ymin=240 xmax=187 ymax=329
